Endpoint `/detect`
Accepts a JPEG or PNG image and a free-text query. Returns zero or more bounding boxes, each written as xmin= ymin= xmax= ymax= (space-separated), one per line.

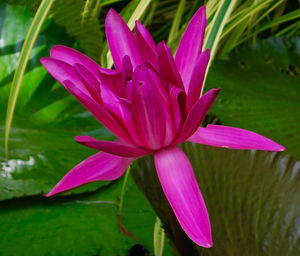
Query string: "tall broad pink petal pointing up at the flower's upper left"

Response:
xmin=105 ymin=9 xmax=142 ymax=70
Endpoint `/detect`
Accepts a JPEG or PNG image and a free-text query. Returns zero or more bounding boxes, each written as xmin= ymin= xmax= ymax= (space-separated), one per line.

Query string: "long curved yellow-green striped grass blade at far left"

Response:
xmin=5 ymin=0 xmax=54 ymax=157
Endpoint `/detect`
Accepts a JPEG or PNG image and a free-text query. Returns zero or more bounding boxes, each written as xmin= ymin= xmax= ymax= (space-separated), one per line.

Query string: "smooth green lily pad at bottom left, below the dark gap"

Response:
xmin=0 ymin=176 xmax=164 ymax=256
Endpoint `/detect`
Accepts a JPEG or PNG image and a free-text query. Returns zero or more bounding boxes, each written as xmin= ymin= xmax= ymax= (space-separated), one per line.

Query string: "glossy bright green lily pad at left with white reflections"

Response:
xmin=0 ymin=3 xmax=112 ymax=200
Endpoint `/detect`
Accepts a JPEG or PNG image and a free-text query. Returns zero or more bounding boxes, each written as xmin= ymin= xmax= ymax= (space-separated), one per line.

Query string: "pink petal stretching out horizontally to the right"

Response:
xmin=187 ymin=125 xmax=285 ymax=151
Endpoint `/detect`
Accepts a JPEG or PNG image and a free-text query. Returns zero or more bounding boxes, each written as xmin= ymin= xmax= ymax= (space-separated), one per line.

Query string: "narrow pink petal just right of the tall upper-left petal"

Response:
xmin=135 ymin=21 xmax=157 ymax=66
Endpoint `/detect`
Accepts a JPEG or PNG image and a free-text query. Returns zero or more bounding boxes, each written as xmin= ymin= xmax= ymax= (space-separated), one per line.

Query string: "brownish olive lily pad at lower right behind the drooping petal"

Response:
xmin=132 ymin=143 xmax=300 ymax=256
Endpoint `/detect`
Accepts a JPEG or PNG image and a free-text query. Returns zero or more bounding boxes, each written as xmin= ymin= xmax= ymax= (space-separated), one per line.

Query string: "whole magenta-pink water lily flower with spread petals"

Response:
xmin=41 ymin=7 xmax=284 ymax=248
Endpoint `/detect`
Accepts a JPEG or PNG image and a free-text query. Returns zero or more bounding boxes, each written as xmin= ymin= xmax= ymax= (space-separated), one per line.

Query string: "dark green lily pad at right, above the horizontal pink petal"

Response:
xmin=207 ymin=38 xmax=300 ymax=160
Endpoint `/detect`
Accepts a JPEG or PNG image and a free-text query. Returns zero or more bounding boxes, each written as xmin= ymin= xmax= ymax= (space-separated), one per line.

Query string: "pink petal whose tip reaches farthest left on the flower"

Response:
xmin=40 ymin=57 xmax=89 ymax=94
